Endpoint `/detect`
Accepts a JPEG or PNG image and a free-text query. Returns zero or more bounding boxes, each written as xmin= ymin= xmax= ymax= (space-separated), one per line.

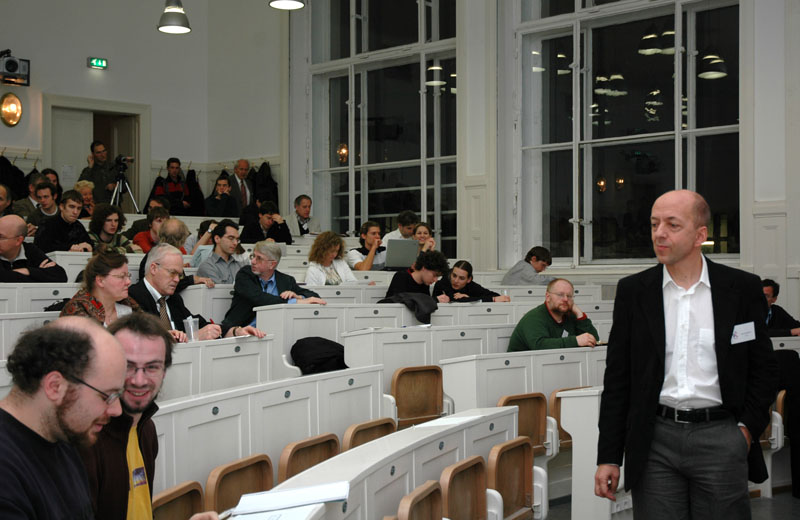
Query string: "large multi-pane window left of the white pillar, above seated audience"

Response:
xmin=311 ymin=0 xmax=457 ymax=258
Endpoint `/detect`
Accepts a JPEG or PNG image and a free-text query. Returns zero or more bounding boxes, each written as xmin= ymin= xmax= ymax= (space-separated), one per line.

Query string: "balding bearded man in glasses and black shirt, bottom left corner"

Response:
xmin=0 ymin=317 xmax=125 ymax=519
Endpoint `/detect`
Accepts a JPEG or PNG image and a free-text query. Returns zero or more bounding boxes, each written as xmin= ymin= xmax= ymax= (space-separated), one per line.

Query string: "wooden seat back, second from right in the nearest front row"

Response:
xmin=439 ymin=455 xmax=486 ymax=520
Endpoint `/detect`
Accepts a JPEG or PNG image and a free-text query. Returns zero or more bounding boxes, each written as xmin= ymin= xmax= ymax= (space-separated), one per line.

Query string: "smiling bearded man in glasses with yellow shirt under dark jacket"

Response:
xmin=80 ymin=312 xmax=219 ymax=520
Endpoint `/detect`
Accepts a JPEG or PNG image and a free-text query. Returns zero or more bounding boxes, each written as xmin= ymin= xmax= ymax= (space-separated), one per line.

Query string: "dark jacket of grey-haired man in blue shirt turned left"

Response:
xmin=220 ymin=265 xmax=319 ymax=336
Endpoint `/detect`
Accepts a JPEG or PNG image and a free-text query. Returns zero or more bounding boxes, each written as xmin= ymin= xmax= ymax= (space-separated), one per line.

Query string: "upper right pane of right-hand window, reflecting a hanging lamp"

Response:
xmin=696 ymin=6 xmax=739 ymax=128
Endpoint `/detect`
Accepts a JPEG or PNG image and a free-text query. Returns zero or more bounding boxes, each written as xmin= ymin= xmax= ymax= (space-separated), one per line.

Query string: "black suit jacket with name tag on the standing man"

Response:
xmin=597 ymin=260 xmax=778 ymax=489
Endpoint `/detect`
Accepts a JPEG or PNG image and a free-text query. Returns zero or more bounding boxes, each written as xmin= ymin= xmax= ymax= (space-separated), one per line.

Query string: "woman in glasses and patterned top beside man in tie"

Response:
xmin=59 ymin=246 xmax=139 ymax=327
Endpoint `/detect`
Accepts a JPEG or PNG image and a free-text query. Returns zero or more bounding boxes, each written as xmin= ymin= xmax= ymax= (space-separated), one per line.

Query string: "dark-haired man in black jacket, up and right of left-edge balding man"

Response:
xmin=33 ymin=190 xmax=92 ymax=253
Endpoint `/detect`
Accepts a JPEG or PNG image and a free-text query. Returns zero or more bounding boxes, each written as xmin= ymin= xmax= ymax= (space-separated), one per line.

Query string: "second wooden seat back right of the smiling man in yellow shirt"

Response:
xmin=206 ymin=453 xmax=272 ymax=511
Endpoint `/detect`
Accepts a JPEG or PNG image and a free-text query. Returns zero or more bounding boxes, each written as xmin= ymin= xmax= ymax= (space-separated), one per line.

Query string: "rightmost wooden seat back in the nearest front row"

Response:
xmin=487 ymin=436 xmax=533 ymax=520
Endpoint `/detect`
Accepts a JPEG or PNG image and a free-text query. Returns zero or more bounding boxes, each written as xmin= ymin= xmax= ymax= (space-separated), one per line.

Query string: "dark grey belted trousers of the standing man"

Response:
xmin=631 ymin=416 xmax=750 ymax=520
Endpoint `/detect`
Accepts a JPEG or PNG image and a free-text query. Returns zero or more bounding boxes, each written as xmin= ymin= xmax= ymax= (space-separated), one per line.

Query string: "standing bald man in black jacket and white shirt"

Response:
xmin=595 ymin=190 xmax=777 ymax=519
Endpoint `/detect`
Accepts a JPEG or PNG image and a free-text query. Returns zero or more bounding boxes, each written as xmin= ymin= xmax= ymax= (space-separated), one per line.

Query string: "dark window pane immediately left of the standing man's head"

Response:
xmin=585 ymin=141 xmax=675 ymax=259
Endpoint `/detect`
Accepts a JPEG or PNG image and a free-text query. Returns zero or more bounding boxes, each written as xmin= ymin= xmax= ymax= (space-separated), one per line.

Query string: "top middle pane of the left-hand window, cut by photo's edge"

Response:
xmin=366 ymin=0 xmax=419 ymax=51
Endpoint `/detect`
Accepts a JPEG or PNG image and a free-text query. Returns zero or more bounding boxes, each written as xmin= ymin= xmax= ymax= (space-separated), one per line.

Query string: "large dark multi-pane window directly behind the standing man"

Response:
xmin=517 ymin=0 xmax=739 ymax=263
